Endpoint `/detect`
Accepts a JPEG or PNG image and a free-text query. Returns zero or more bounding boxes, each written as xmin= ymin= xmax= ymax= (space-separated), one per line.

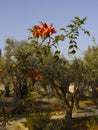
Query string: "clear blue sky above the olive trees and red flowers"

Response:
xmin=0 ymin=0 xmax=98 ymax=57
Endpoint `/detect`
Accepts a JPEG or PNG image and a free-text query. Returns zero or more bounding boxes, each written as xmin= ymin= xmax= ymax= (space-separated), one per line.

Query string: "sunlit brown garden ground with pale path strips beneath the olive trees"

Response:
xmin=0 ymin=98 xmax=98 ymax=130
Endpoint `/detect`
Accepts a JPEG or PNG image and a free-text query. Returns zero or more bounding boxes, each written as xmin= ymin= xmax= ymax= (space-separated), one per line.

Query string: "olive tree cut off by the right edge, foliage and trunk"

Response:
xmin=84 ymin=45 xmax=98 ymax=104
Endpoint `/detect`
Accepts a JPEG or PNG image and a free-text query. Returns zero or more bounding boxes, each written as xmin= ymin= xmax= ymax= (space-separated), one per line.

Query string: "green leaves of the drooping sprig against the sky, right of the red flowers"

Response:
xmin=65 ymin=17 xmax=90 ymax=54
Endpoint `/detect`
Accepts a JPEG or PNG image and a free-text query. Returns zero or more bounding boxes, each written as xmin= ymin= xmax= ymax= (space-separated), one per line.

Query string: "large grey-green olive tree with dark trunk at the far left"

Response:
xmin=1 ymin=39 xmax=37 ymax=99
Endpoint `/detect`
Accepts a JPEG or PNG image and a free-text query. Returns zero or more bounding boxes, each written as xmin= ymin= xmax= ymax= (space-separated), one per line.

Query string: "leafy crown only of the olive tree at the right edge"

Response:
xmin=84 ymin=45 xmax=98 ymax=86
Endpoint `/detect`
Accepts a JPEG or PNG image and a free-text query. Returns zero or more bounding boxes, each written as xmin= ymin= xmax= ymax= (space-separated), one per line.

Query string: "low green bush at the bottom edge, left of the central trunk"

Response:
xmin=27 ymin=113 xmax=66 ymax=130
